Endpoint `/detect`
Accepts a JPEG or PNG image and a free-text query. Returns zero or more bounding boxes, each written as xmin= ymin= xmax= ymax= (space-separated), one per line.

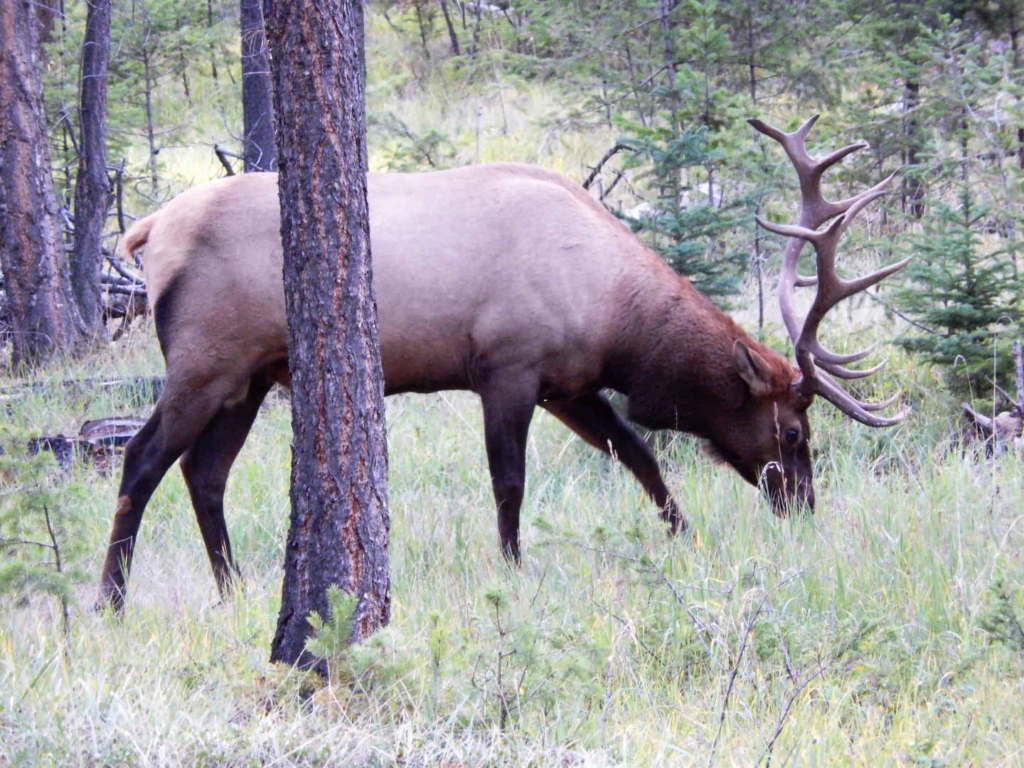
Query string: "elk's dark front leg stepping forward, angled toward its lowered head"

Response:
xmin=541 ymin=394 xmax=686 ymax=536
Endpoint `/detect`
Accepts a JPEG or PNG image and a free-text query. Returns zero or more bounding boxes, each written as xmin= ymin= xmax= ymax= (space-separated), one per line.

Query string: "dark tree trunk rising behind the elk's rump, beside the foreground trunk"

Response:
xmin=241 ymin=0 xmax=278 ymax=173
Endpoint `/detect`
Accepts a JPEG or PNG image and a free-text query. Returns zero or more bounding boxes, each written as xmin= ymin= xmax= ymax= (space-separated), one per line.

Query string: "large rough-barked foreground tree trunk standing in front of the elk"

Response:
xmin=264 ymin=0 xmax=391 ymax=671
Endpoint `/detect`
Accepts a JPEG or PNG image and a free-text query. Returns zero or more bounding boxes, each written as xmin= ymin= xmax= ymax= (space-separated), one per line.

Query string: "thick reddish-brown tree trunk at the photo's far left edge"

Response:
xmin=0 ymin=0 xmax=85 ymax=366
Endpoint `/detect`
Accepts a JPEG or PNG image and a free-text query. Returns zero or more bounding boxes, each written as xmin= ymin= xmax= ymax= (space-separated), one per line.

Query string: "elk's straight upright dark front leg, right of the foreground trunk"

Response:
xmin=480 ymin=382 xmax=537 ymax=565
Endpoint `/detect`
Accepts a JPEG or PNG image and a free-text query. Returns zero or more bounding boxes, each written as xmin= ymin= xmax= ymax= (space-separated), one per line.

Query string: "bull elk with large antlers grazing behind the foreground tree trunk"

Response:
xmin=100 ymin=119 xmax=902 ymax=611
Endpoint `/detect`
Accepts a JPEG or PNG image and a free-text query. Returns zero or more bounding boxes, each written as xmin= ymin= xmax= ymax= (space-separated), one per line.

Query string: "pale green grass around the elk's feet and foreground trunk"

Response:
xmin=0 ymin=321 xmax=1024 ymax=766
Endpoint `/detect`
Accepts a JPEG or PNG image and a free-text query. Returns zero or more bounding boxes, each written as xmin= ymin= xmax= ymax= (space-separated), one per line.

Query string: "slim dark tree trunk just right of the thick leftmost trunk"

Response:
xmin=71 ymin=0 xmax=111 ymax=338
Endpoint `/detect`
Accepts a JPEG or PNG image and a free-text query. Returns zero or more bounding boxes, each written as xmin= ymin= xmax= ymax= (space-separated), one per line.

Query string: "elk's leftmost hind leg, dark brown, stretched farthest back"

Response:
xmin=97 ymin=385 xmax=233 ymax=613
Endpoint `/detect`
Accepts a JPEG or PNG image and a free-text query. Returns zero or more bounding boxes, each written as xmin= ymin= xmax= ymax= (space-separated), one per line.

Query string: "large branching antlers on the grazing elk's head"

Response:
xmin=748 ymin=115 xmax=913 ymax=427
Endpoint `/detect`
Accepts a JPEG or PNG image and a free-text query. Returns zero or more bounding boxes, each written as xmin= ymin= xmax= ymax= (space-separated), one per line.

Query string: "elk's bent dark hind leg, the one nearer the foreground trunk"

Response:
xmin=180 ymin=374 xmax=273 ymax=597
